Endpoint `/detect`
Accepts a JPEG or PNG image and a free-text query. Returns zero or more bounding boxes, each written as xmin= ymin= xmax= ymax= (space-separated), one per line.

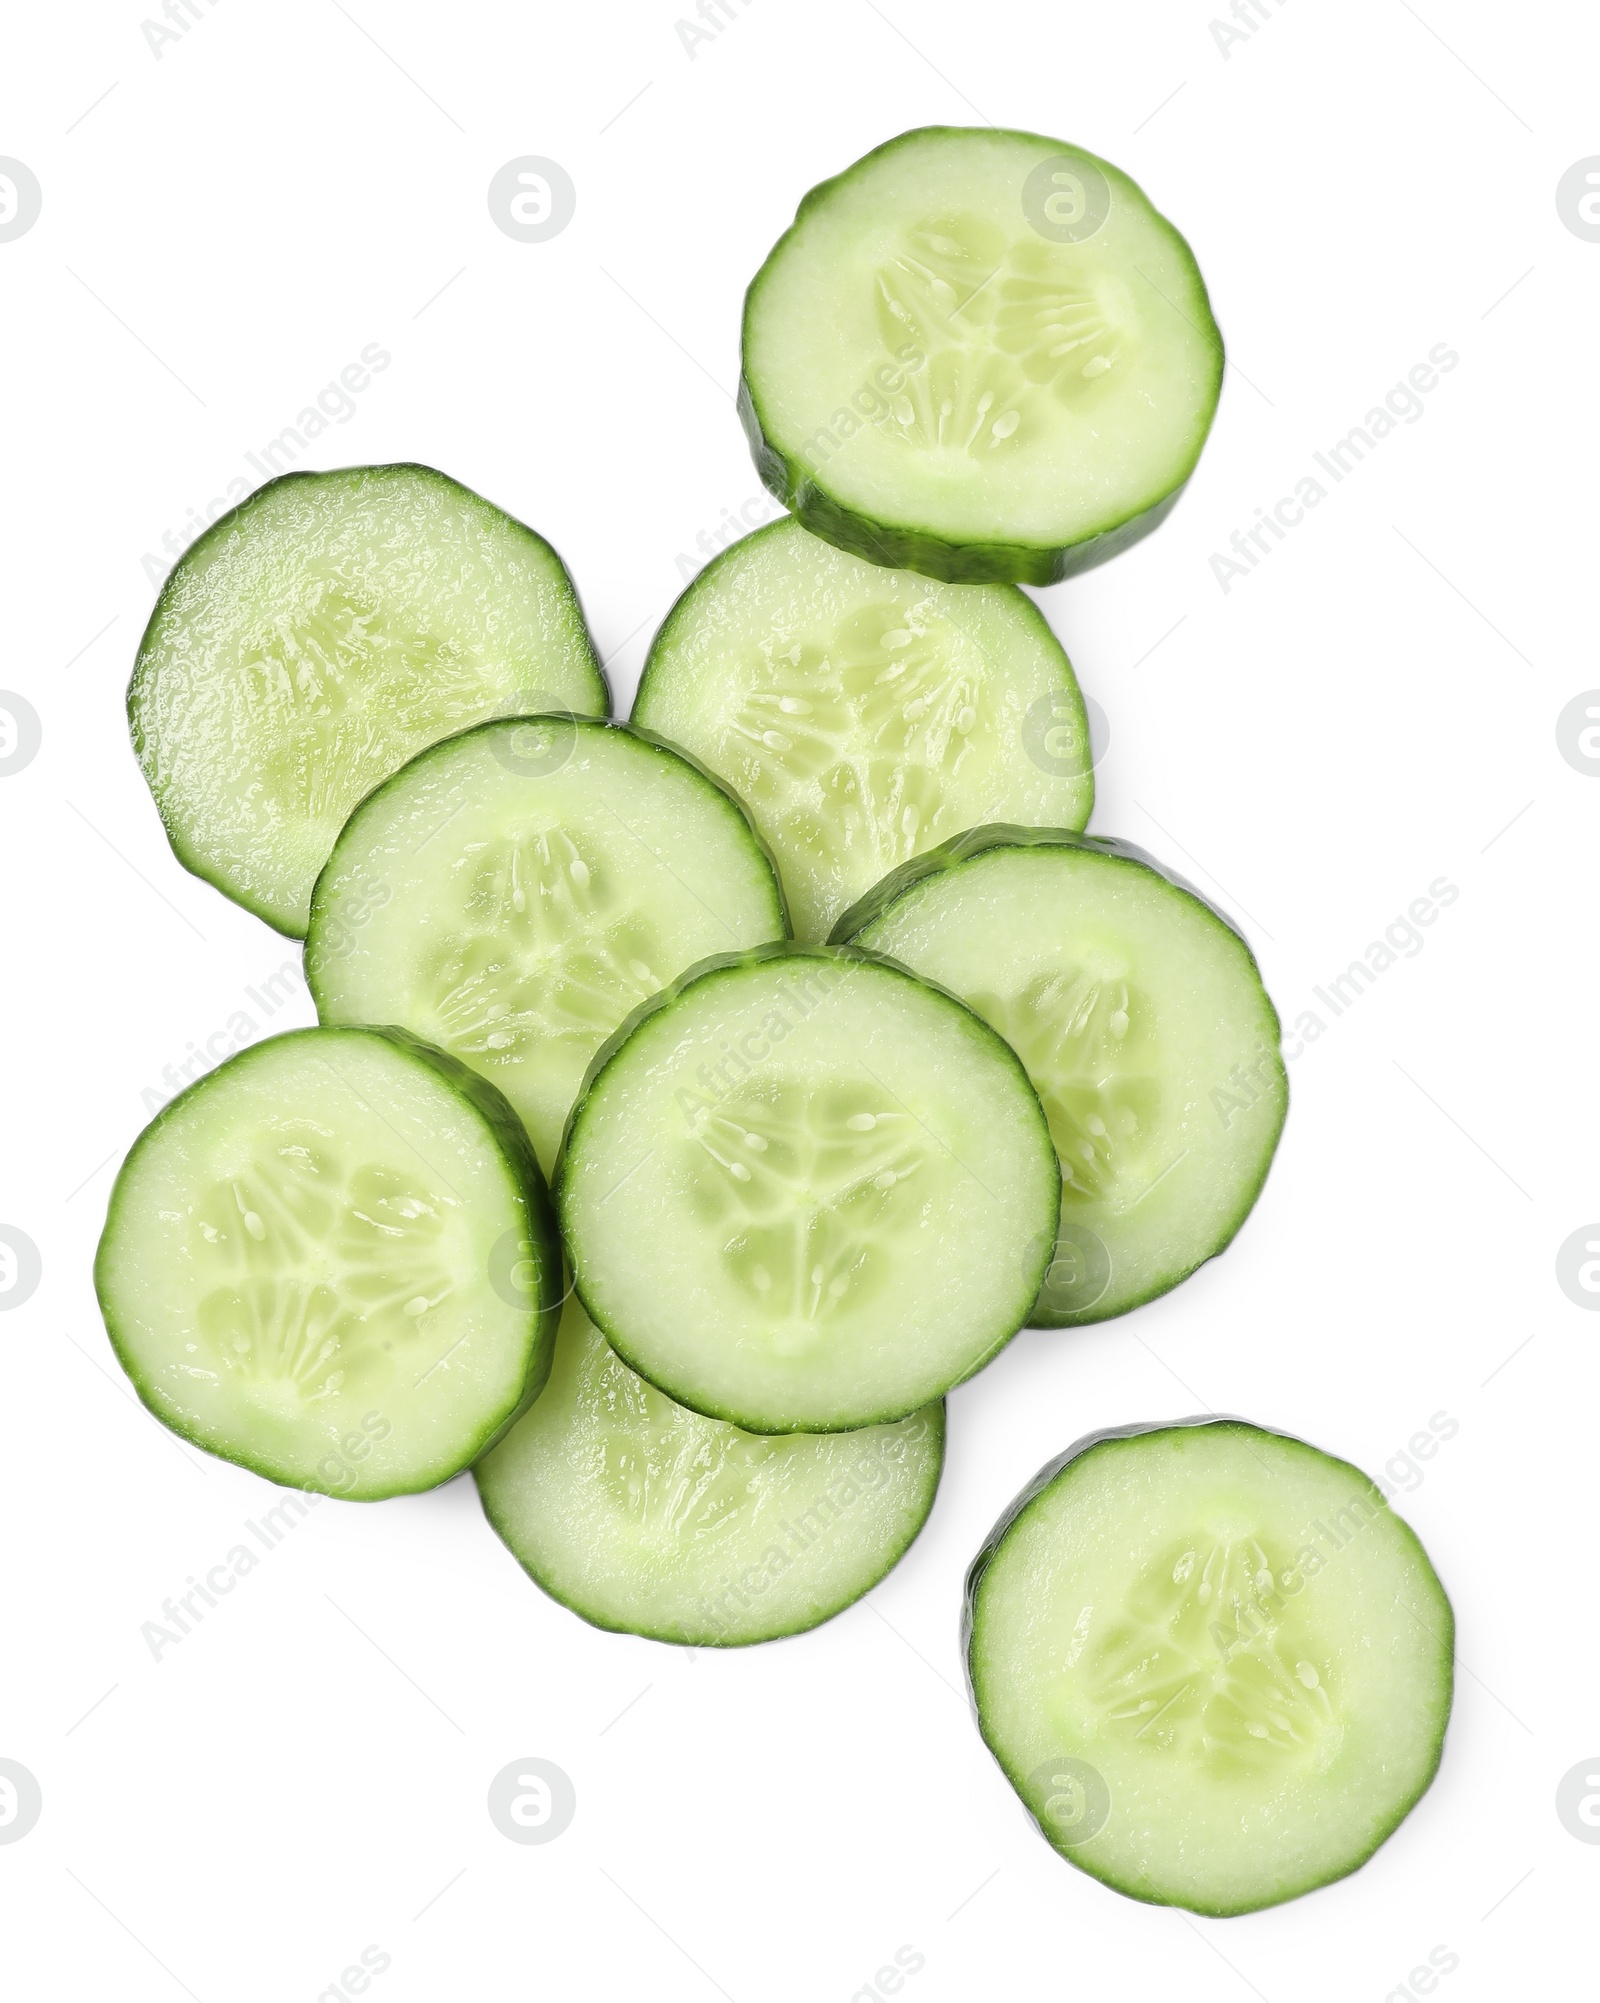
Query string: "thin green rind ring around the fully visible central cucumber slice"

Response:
xmin=551 ymin=941 xmax=1061 ymax=1436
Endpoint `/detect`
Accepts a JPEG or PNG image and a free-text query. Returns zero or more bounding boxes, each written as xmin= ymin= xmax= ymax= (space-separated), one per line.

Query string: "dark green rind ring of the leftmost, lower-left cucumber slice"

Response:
xmin=94 ymin=1024 xmax=565 ymax=1502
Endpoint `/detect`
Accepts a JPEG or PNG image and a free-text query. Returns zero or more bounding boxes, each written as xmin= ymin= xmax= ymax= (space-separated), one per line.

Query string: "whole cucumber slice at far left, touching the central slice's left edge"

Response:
xmin=94 ymin=1030 xmax=561 ymax=1502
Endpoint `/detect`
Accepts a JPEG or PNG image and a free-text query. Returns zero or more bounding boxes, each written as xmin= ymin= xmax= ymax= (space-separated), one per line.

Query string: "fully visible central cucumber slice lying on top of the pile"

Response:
xmin=557 ymin=945 xmax=1059 ymax=1432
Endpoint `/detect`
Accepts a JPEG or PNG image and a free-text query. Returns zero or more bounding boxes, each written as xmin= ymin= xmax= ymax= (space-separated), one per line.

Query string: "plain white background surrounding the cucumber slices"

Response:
xmin=0 ymin=0 xmax=1600 ymax=2003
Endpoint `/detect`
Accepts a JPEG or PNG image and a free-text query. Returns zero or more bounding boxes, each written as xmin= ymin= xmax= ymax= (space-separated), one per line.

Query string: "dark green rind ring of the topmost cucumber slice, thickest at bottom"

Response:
xmin=739 ymin=126 xmax=1226 ymax=585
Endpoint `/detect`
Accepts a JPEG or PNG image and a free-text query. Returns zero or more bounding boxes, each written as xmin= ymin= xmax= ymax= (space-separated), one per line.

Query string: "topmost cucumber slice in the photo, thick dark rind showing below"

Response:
xmin=739 ymin=126 xmax=1222 ymax=585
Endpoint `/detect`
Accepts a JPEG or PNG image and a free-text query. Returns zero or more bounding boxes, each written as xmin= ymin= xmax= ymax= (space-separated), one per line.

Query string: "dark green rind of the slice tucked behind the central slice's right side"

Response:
xmin=829 ymin=823 xmax=1290 ymax=1328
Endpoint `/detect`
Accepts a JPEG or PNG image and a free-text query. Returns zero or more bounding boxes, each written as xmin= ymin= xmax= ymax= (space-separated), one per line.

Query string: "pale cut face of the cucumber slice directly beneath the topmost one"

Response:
xmin=633 ymin=521 xmax=1093 ymax=939
